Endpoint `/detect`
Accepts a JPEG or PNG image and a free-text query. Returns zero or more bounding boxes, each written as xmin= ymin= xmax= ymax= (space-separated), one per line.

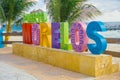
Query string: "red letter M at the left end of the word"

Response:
xmin=22 ymin=23 xmax=32 ymax=44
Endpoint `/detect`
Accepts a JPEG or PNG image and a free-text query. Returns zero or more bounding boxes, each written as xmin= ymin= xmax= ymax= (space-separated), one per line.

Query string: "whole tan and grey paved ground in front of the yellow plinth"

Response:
xmin=0 ymin=48 xmax=120 ymax=80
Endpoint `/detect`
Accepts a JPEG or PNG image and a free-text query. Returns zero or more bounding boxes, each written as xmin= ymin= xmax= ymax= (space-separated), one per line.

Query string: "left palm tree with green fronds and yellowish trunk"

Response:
xmin=0 ymin=0 xmax=35 ymax=41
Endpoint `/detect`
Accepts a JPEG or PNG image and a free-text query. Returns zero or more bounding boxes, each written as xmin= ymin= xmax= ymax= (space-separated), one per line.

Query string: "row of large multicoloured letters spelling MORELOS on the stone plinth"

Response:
xmin=22 ymin=21 xmax=107 ymax=54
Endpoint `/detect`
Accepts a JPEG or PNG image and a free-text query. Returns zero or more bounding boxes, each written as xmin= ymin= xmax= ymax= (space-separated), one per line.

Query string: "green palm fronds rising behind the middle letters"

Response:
xmin=47 ymin=0 xmax=101 ymax=22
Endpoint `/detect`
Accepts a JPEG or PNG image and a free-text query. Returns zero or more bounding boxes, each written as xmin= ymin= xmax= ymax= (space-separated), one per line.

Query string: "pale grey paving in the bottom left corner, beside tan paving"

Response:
xmin=0 ymin=62 xmax=38 ymax=80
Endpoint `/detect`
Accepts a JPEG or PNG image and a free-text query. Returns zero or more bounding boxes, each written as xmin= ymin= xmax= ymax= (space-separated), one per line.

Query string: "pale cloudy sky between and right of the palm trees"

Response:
xmin=32 ymin=0 xmax=120 ymax=22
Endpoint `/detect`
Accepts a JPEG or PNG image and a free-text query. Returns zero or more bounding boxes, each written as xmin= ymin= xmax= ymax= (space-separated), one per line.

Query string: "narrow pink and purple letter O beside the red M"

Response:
xmin=32 ymin=24 xmax=40 ymax=45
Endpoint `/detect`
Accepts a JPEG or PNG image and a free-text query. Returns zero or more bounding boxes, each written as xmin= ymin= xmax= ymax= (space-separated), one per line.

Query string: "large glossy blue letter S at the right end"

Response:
xmin=86 ymin=21 xmax=107 ymax=54
